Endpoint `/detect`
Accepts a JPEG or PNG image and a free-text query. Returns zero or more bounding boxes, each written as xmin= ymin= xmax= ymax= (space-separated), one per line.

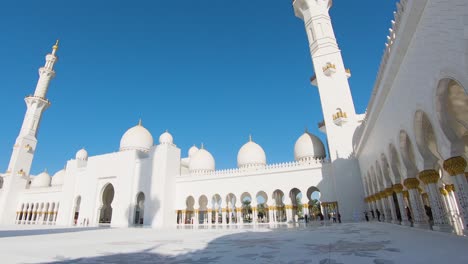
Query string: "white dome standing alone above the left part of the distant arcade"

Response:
xmin=237 ymin=138 xmax=266 ymax=168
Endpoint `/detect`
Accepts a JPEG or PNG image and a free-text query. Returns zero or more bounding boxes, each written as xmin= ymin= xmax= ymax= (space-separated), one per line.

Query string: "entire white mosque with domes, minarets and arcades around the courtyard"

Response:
xmin=0 ymin=0 xmax=468 ymax=234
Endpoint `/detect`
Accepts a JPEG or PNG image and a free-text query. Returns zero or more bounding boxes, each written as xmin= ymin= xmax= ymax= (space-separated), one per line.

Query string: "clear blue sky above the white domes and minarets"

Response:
xmin=0 ymin=0 xmax=396 ymax=174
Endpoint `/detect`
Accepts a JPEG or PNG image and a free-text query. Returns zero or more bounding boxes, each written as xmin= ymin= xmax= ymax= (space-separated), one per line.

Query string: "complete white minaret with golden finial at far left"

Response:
xmin=0 ymin=40 xmax=59 ymax=223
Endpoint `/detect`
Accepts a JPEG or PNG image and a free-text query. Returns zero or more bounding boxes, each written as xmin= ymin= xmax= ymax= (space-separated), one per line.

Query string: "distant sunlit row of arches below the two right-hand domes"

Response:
xmin=176 ymin=187 xmax=339 ymax=225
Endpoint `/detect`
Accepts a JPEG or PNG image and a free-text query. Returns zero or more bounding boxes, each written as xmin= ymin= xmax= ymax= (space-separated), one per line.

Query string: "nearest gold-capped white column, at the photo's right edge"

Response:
xmin=443 ymin=156 xmax=468 ymax=235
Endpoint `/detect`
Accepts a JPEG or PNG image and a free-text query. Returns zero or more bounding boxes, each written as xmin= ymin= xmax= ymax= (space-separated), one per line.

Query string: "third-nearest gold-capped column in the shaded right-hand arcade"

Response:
xmin=404 ymin=178 xmax=430 ymax=229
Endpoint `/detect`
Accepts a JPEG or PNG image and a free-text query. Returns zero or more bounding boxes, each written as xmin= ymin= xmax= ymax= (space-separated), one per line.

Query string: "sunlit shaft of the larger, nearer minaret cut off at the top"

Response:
xmin=293 ymin=0 xmax=357 ymax=161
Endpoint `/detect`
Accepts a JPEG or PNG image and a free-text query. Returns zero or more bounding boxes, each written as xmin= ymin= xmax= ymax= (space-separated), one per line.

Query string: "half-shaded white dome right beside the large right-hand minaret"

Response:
xmin=294 ymin=131 xmax=326 ymax=161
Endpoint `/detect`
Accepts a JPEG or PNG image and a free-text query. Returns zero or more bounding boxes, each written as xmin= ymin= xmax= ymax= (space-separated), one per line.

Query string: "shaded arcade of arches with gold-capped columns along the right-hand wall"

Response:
xmin=363 ymin=79 xmax=468 ymax=234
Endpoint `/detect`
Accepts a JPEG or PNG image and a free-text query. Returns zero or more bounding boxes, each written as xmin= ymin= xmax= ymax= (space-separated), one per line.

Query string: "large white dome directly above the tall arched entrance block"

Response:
xmin=120 ymin=121 xmax=153 ymax=152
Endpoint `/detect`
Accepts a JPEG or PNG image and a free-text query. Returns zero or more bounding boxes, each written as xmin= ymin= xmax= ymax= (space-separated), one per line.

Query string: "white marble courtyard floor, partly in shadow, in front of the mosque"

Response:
xmin=0 ymin=223 xmax=468 ymax=264
